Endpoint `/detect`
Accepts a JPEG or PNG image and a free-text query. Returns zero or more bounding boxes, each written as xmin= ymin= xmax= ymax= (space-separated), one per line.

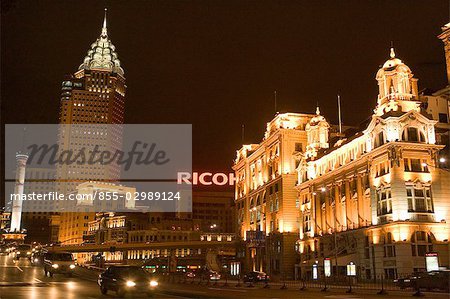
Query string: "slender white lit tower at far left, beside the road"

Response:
xmin=10 ymin=152 xmax=28 ymax=233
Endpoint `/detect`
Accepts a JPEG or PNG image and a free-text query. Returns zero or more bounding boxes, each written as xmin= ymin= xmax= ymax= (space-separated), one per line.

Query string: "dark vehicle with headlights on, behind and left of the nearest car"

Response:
xmin=44 ymin=252 xmax=76 ymax=277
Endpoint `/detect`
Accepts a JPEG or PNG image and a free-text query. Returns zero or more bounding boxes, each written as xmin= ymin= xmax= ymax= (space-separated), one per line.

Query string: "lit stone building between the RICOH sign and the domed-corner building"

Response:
xmin=233 ymin=113 xmax=314 ymax=278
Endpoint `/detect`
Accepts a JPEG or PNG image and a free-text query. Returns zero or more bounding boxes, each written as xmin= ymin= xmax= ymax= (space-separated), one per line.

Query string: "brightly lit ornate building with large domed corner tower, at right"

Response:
xmin=295 ymin=49 xmax=450 ymax=278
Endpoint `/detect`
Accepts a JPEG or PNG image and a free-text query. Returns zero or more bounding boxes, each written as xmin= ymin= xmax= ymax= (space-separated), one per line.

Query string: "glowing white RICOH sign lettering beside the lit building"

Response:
xmin=177 ymin=172 xmax=236 ymax=186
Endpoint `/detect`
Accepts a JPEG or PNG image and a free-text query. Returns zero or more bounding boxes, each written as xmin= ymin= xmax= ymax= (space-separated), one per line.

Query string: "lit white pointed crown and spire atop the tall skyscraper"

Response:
xmin=78 ymin=9 xmax=124 ymax=76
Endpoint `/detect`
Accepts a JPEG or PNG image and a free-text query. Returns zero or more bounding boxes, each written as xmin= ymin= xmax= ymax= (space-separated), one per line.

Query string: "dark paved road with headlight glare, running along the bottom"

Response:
xmin=0 ymin=256 xmax=449 ymax=299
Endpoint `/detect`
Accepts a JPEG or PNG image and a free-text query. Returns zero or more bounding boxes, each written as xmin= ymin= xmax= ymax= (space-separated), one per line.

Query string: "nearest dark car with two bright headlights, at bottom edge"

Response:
xmin=97 ymin=265 xmax=159 ymax=297
